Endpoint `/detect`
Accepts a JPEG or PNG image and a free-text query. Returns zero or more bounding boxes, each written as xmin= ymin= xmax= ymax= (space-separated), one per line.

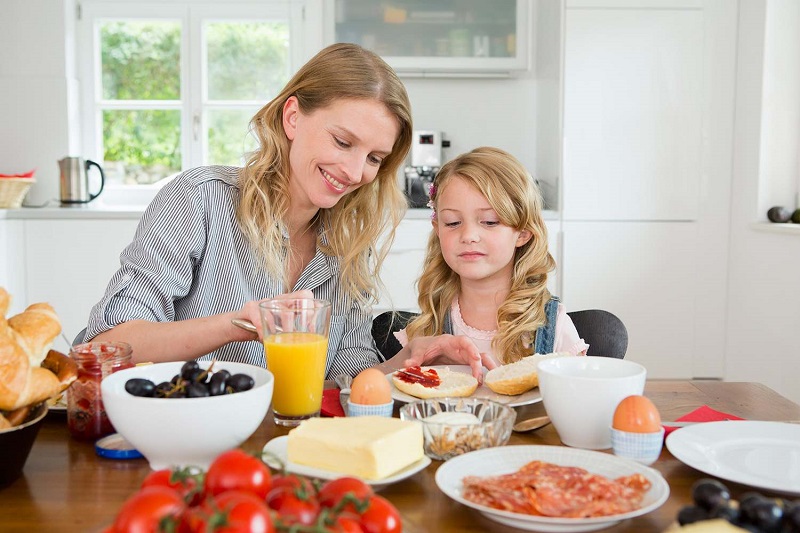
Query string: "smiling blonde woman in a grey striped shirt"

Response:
xmin=85 ymin=44 xmax=412 ymax=377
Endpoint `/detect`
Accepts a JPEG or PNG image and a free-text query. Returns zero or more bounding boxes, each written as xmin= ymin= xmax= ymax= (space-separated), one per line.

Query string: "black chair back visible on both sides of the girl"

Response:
xmin=372 ymin=309 xmax=628 ymax=361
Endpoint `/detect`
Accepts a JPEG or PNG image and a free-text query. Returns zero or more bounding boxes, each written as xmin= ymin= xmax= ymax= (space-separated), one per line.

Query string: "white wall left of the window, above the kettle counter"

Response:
xmin=0 ymin=0 xmax=80 ymax=205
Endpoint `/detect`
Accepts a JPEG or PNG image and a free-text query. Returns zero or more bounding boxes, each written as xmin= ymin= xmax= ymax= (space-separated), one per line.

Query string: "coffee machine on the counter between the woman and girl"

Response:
xmin=404 ymin=130 xmax=450 ymax=208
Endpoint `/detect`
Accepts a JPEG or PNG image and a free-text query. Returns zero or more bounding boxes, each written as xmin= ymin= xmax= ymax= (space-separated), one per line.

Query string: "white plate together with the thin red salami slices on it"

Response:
xmin=436 ymin=446 xmax=669 ymax=532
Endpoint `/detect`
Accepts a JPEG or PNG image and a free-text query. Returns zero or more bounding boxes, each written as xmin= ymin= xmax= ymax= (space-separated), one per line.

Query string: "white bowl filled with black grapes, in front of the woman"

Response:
xmin=101 ymin=361 xmax=274 ymax=470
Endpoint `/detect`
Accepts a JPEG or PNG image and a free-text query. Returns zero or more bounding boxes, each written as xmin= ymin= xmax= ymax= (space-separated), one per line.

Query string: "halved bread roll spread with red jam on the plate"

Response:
xmin=392 ymin=366 xmax=478 ymax=399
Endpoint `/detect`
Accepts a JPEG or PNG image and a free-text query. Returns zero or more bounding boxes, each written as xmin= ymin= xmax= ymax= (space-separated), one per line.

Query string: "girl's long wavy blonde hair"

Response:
xmin=406 ymin=147 xmax=555 ymax=363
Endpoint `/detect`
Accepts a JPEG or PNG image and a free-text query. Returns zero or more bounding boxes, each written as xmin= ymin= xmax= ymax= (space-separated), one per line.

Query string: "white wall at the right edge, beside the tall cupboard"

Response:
xmin=725 ymin=0 xmax=800 ymax=403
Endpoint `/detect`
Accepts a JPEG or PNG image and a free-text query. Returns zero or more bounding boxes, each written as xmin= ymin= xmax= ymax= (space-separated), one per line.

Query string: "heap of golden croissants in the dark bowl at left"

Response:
xmin=0 ymin=287 xmax=77 ymax=411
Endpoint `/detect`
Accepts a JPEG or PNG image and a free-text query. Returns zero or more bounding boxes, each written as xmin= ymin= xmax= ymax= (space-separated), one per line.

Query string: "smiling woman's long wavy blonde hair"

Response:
xmin=237 ymin=43 xmax=412 ymax=303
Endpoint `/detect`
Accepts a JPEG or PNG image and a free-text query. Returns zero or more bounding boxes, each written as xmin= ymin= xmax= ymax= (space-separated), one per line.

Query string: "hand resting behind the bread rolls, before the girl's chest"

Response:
xmin=403 ymin=335 xmax=497 ymax=383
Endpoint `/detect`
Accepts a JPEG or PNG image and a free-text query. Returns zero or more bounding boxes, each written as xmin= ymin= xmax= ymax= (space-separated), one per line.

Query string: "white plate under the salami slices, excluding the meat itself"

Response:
xmin=436 ymin=446 xmax=669 ymax=532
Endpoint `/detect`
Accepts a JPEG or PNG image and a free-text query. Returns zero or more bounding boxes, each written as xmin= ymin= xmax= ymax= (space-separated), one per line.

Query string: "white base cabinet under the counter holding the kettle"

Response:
xmin=18 ymin=219 xmax=138 ymax=350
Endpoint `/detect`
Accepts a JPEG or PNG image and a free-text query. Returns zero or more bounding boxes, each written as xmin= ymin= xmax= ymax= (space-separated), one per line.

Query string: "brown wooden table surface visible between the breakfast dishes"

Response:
xmin=0 ymin=381 xmax=800 ymax=533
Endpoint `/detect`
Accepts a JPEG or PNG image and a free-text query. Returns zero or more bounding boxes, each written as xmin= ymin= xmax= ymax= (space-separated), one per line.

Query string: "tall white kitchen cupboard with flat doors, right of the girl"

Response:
xmin=561 ymin=0 xmax=737 ymax=378
